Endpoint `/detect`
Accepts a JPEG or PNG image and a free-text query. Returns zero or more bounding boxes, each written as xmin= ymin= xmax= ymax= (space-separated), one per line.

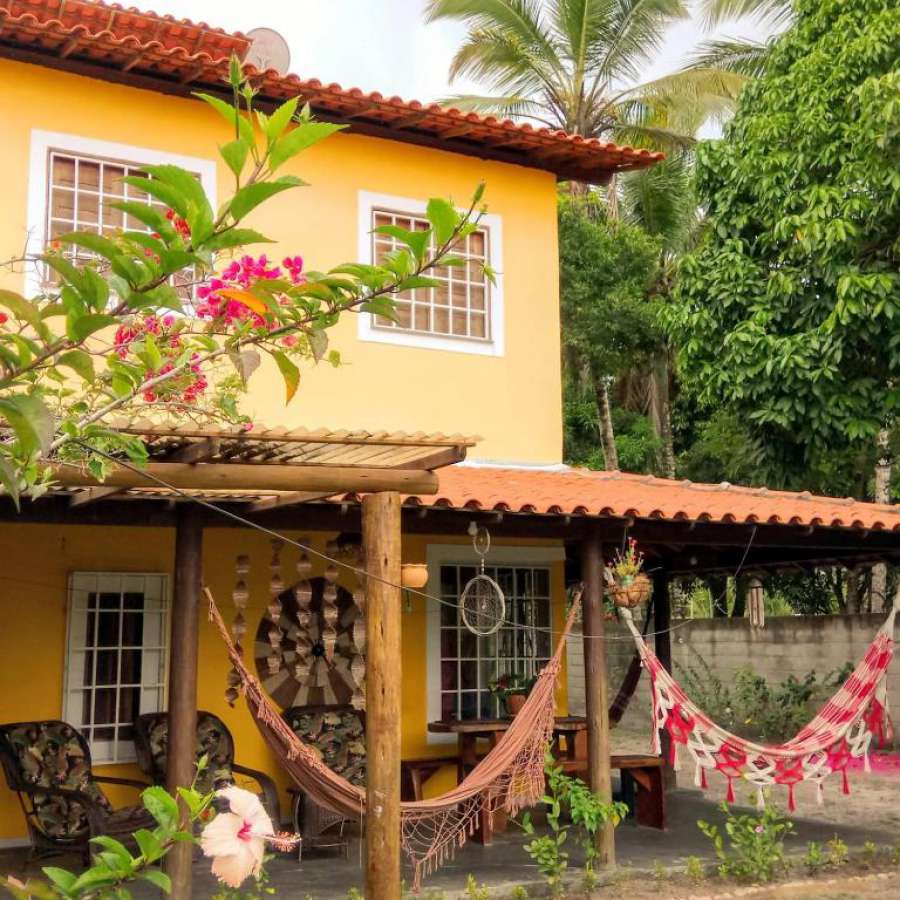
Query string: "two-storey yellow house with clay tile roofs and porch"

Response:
xmin=0 ymin=7 xmax=900 ymax=896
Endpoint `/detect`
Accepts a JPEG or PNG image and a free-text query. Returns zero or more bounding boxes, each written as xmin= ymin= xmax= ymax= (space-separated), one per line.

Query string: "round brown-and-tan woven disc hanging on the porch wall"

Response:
xmin=254 ymin=577 xmax=365 ymax=709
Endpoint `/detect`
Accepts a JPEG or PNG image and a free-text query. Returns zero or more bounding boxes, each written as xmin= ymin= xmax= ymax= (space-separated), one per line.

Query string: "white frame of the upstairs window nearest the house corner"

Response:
xmin=357 ymin=191 xmax=505 ymax=356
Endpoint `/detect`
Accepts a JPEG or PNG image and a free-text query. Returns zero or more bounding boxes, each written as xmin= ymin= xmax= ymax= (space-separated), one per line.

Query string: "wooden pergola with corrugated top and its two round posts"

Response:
xmin=24 ymin=422 xmax=475 ymax=900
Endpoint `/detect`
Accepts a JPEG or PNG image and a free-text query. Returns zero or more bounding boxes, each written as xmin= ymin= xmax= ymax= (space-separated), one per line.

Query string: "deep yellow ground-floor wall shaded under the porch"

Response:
xmin=0 ymin=524 xmax=566 ymax=840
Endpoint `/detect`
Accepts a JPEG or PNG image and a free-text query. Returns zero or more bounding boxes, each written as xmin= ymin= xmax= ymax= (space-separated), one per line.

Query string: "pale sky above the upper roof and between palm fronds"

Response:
xmin=148 ymin=0 xmax=765 ymax=109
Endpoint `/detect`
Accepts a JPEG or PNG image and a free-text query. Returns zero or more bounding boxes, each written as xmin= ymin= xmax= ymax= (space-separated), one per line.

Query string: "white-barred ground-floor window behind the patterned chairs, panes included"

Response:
xmin=63 ymin=572 xmax=168 ymax=763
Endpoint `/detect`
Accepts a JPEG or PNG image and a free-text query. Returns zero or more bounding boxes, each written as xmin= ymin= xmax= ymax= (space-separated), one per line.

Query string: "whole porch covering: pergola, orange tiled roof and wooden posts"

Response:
xmin=0 ymin=422 xmax=900 ymax=898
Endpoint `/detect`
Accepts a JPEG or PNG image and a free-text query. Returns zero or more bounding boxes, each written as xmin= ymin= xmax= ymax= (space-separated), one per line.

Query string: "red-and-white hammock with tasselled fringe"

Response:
xmin=621 ymin=591 xmax=900 ymax=812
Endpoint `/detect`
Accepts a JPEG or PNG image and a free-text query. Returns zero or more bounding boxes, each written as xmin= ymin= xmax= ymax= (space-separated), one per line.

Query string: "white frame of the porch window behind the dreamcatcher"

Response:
xmin=424 ymin=544 xmax=566 ymax=746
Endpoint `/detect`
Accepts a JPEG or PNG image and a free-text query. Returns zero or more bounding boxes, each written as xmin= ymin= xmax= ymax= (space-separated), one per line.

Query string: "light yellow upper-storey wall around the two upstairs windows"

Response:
xmin=0 ymin=60 xmax=562 ymax=463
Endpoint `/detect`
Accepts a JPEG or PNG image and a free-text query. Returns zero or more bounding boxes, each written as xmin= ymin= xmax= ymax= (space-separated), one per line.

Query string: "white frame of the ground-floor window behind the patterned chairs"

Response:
xmin=62 ymin=571 xmax=171 ymax=765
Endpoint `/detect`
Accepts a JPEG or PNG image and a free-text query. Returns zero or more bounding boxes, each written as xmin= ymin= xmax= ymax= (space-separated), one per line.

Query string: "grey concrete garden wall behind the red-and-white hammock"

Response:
xmin=568 ymin=613 xmax=900 ymax=727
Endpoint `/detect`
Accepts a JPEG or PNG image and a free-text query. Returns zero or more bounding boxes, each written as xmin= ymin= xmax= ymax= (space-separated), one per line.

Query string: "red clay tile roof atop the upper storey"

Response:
xmin=0 ymin=0 xmax=663 ymax=182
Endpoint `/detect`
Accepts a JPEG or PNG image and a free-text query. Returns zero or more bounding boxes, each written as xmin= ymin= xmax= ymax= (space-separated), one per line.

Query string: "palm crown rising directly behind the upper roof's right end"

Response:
xmin=426 ymin=0 xmax=744 ymax=150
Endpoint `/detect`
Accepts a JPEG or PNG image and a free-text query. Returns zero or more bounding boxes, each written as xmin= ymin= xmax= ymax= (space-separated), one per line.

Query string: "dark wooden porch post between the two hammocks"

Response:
xmin=581 ymin=535 xmax=616 ymax=866
